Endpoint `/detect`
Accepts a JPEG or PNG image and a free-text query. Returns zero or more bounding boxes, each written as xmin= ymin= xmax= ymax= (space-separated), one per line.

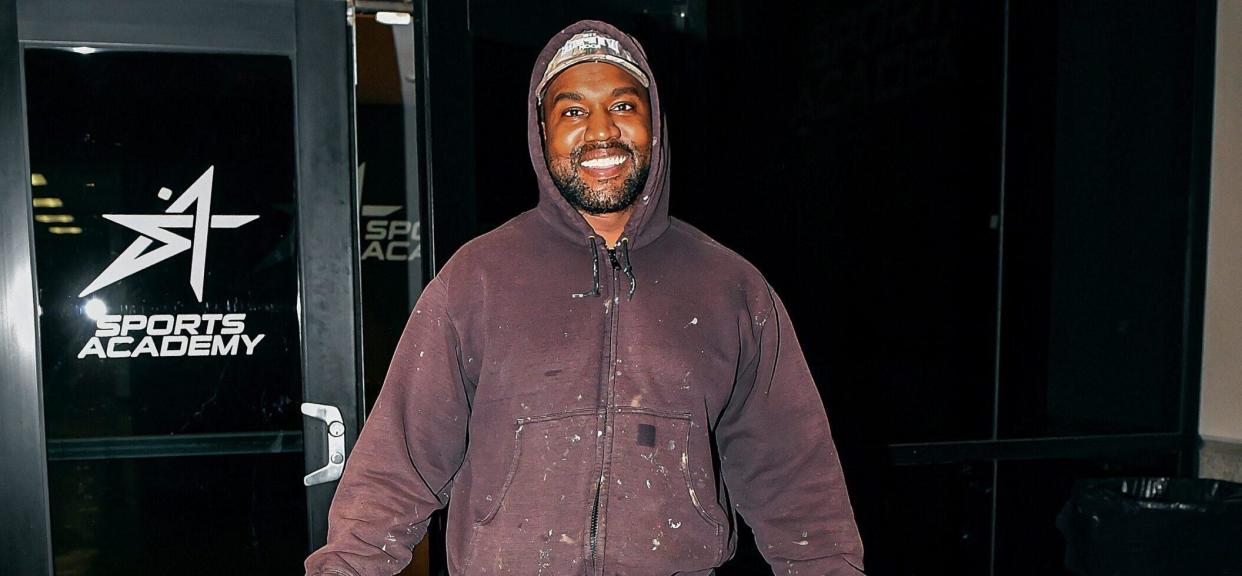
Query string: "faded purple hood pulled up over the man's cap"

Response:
xmin=527 ymin=20 xmax=669 ymax=250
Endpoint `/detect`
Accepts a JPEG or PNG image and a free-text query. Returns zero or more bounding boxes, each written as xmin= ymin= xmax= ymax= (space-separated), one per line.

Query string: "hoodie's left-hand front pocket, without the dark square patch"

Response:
xmin=465 ymin=410 xmax=599 ymax=576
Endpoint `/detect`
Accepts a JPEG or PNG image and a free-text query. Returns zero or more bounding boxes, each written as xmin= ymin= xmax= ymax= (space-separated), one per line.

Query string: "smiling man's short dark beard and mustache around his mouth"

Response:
xmin=548 ymin=142 xmax=651 ymax=215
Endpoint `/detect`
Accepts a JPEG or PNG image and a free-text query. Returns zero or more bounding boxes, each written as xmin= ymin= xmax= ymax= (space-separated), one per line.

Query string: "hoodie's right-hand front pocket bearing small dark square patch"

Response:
xmin=604 ymin=407 xmax=728 ymax=574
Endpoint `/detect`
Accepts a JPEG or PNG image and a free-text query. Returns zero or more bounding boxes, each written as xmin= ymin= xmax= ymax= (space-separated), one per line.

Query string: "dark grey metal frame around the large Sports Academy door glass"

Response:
xmin=0 ymin=0 xmax=363 ymax=568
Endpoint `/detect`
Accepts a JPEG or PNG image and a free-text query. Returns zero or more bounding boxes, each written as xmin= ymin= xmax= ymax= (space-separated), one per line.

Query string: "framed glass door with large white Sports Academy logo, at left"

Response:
xmin=0 ymin=0 xmax=361 ymax=575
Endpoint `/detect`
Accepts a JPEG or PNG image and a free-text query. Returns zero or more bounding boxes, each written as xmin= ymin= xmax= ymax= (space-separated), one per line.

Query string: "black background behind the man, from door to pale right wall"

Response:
xmin=425 ymin=0 xmax=1215 ymax=576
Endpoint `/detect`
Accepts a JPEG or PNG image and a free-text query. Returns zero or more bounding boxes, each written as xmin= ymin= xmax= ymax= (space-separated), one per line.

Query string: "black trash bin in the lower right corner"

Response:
xmin=1057 ymin=478 xmax=1242 ymax=576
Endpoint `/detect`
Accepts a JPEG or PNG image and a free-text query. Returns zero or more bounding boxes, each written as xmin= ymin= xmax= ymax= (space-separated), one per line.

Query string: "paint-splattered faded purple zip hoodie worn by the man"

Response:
xmin=306 ymin=21 xmax=862 ymax=576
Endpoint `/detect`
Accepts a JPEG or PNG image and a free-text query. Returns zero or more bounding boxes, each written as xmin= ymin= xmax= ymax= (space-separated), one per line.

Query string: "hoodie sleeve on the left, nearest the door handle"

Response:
xmin=306 ymin=277 xmax=469 ymax=576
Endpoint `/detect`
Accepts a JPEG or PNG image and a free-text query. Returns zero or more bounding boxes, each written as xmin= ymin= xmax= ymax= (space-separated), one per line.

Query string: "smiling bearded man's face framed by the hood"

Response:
xmin=543 ymin=62 xmax=651 ymax=215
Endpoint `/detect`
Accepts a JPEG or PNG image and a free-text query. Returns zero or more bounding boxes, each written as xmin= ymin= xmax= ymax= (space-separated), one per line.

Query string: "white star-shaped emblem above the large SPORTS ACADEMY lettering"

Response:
xmin=78 ymin=166 xmax=258 ymax=302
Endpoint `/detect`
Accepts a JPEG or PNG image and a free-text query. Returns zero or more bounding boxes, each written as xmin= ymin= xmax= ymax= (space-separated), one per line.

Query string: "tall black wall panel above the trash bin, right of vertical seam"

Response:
xmin=1000 ymin=0 xmax=1195 ymax=437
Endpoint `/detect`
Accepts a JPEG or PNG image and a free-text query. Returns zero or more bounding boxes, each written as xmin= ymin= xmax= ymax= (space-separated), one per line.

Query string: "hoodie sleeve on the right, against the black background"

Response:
xmin=717 ymin=287 xmax=862 ymax=576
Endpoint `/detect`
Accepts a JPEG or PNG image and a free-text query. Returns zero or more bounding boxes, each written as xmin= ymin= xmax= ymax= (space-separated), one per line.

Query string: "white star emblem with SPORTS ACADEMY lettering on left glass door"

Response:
xmin=77 ymin=166 xmax=263 ymax=359
